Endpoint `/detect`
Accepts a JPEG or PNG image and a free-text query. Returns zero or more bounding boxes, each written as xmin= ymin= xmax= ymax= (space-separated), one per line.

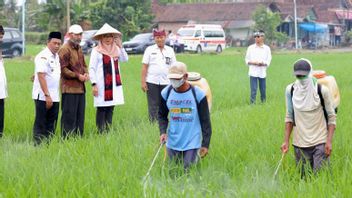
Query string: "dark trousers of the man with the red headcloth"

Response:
xmin=147 ymin=83 xmax=167 ymax=122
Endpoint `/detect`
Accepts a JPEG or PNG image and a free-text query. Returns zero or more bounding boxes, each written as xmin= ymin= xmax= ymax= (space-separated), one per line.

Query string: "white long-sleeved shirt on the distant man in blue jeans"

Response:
xmin=245 ymin=44 xmax=271 ymax=78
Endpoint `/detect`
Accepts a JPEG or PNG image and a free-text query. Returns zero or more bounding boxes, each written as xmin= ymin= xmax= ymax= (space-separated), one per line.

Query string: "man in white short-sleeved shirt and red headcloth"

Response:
xmin=141 ymin=30 xmax=176 ymax=122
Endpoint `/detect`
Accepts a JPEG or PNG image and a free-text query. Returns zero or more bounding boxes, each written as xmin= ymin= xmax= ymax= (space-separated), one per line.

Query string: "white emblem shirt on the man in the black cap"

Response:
xmin=32 ymin=47 xmax=61 ymax=102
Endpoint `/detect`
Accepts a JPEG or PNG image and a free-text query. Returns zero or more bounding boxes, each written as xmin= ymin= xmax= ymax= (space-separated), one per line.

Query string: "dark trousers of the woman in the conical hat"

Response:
xmin=95 ymin=106 xmax=114 ymax=133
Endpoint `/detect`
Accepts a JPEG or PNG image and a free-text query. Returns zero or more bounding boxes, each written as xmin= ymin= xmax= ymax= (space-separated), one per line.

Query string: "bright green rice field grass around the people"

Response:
xmin=0 ymin=46 xmax=352 ymax=197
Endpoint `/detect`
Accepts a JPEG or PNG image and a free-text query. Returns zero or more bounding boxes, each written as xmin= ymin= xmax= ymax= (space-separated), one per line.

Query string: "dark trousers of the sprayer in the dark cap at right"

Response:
xmin=294 ymin=144 xmax=329 ymax=177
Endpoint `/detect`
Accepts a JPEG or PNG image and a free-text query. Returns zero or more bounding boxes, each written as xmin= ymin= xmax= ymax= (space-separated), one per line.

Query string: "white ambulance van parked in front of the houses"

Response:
xmin=177 ymin=24 xmax=225 ymax=53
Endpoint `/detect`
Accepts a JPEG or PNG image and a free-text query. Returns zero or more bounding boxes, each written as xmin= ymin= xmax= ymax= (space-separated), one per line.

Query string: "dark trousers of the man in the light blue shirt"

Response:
xmin=167 ymin=148 xmax=198 ymax=170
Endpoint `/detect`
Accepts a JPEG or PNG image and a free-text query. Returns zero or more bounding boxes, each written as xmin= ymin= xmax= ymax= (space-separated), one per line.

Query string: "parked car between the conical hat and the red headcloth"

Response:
xmin=122 ymin=33 xmax=155 ymax=54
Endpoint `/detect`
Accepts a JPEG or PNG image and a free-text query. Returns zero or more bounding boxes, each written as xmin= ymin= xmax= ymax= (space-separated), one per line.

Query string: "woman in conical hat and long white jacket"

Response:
xmin=89 ymin=23 xmax=128 ymax=133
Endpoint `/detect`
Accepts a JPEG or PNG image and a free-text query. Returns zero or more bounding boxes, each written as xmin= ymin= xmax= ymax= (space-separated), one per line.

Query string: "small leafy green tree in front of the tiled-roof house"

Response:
xmin=252 ymin=5 xmax=288 ymax=45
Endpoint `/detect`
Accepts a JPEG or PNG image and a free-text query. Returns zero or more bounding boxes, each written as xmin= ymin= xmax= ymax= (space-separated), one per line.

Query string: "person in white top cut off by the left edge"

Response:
xmin=0 ymin=25 xmax=7 ymax=137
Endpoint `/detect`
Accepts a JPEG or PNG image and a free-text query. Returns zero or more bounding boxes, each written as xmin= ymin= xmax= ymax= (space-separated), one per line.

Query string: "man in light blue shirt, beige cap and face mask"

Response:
xmin=159 ymin=62 xmax=212 ymax=170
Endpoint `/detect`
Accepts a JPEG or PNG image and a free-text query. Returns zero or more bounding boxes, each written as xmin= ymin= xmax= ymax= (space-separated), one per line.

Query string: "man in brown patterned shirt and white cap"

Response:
xmin=59 ymin=24 xmax=89 ymax=138
